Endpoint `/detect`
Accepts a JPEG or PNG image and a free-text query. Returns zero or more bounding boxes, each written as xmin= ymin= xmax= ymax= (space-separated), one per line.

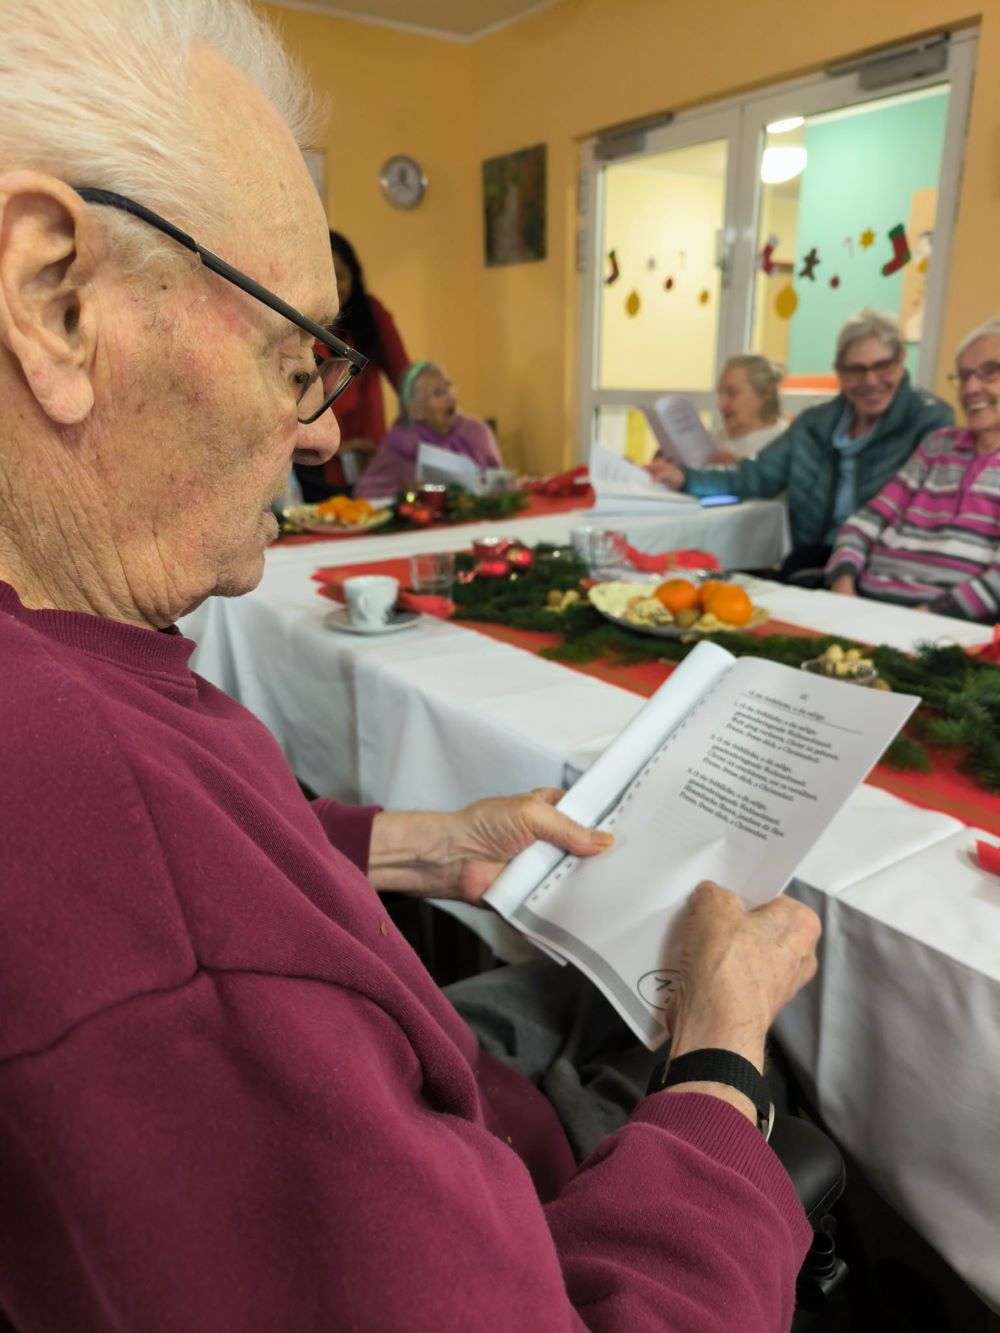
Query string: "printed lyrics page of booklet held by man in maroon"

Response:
xmin=511 ymin=657 xmax=919 ymax=1049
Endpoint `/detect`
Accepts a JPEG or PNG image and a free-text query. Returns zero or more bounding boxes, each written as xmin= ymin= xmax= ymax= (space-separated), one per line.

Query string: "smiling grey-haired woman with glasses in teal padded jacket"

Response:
xmin=649 ymin=311 xmax=955 ymax=581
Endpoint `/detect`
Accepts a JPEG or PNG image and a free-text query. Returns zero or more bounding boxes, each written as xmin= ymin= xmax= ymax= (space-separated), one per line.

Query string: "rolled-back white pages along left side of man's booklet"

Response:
xmin=484 ymin=641 xmax=736 ymax=918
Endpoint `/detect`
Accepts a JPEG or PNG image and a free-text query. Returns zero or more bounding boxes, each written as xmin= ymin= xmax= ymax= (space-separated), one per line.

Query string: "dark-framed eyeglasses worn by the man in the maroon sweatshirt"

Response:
xmin=75 ymin=185 xmax=368 ymax=425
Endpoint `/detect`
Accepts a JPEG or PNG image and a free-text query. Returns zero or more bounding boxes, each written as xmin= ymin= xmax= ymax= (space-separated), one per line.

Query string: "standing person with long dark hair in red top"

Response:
xmin=295 ymin=232 xmax=409 ymax=504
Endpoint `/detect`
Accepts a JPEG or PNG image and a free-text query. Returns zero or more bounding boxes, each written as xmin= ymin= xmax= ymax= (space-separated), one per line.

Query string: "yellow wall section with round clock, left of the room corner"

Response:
xmin=265 ymin=5 xmax=484 ymax=420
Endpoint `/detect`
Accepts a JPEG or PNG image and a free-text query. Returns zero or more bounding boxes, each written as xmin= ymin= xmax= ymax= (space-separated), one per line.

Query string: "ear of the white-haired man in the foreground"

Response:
xmin=0 ymin=171 xmax=97 ymax=425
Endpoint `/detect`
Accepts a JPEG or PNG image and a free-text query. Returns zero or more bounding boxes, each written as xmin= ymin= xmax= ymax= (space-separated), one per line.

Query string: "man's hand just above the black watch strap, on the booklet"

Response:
xmin=669 ymin=881 xmax=820 ymax=1069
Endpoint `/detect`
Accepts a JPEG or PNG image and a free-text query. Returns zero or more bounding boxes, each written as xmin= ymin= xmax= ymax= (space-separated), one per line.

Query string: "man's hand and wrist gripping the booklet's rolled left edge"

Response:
xmin=368 ymin=788 xmax=613 ymax=904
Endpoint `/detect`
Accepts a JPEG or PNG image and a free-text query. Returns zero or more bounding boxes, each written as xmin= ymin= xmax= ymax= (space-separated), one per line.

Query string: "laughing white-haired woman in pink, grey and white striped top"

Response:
xmin=827 ymin=320 xmax=1000 ymax=623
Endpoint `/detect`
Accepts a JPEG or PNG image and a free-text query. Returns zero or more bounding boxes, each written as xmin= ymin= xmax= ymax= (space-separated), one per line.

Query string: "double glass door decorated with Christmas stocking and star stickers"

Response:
xmin=579 ymin=31 xmax=977 ymax=461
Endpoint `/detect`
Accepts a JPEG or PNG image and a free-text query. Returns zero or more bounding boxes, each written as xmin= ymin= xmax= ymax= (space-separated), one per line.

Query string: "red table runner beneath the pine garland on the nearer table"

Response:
xmin=319 ymin=559 xmax=1000 ymax=834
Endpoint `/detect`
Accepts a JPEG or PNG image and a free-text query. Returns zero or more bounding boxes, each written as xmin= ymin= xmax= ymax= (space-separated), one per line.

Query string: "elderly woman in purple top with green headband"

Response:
xmin=355 ymin=361 xmax=504 ymax=496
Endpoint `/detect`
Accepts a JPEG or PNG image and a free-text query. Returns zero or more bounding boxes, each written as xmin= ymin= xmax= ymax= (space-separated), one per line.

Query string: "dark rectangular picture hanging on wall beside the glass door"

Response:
xmin=483 ymin=144 xmax=545 ymax=268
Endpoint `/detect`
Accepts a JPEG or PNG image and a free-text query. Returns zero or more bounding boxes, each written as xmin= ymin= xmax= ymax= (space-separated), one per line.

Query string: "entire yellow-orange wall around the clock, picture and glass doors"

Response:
xmin=271 ymin=0 xmax=1000 ymax=469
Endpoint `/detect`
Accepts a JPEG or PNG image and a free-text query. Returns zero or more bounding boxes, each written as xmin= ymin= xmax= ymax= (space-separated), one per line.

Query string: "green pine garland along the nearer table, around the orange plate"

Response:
xmin=455 ymin=545 xmax=1000 ymax=794
